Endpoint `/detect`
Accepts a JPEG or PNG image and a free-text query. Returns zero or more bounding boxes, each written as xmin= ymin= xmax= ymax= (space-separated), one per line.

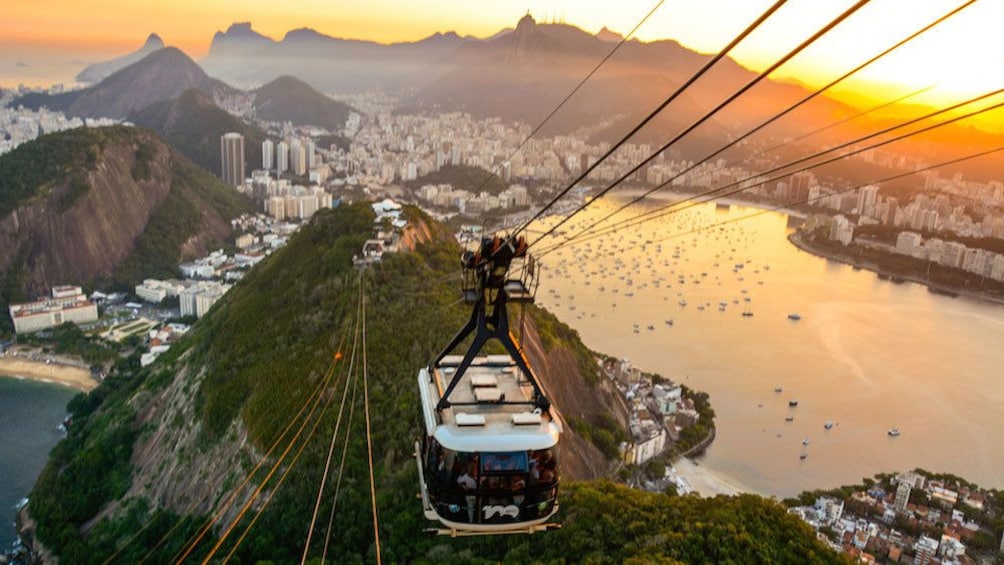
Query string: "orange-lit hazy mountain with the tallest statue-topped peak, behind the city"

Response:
xmin=414 ymin=15 xmax=851 ymax=156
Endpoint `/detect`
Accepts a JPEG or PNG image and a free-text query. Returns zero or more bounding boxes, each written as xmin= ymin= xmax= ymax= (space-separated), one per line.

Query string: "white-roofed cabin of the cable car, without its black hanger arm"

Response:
xmin=419 ymin=355 xmax=561 ymax=535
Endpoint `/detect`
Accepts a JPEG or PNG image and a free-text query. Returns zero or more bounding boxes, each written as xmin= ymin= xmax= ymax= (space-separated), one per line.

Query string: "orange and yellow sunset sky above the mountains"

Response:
xmin=0 ymin=0 xmax=1004 ymax=115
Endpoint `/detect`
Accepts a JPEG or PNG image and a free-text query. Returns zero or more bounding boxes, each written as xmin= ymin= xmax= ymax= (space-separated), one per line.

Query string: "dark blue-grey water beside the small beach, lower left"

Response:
xmin=0 ymin=376 xmax=76 ymax=548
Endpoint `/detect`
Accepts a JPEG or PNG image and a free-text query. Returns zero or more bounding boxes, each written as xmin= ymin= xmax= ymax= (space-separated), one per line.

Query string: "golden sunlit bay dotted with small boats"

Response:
xmin=534 ymin=196 xmax=1004 ymax=496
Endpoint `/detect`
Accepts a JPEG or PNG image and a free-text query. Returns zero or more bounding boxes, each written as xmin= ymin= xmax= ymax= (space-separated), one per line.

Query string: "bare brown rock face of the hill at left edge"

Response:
xmin=0 ymin=127 xmax=249 ymax=297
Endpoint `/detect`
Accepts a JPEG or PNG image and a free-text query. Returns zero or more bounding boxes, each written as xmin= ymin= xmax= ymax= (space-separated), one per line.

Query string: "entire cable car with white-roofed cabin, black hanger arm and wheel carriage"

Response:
xmin=416 ymin=236 xmax=562 ymax=536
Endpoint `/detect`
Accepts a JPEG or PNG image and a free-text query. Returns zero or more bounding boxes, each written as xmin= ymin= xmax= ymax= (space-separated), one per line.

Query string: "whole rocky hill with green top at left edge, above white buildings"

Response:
xmin=0 ymin=125 xmax=253 ymax=333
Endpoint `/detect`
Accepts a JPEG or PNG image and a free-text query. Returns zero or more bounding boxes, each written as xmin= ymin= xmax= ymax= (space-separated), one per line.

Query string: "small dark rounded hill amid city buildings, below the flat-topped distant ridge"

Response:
xmin=252 ymin=76 xmax=352 ymax=131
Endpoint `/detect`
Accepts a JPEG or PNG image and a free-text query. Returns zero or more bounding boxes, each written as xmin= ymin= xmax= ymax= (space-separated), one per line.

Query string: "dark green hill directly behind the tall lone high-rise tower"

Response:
xmin=129 ymin=88 xmax=267 ymax=176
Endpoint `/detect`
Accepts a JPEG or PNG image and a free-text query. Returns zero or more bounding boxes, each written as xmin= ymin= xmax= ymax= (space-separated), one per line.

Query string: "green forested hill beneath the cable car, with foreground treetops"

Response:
xmin=19 ymin=204 xmax=843 ymax=563
